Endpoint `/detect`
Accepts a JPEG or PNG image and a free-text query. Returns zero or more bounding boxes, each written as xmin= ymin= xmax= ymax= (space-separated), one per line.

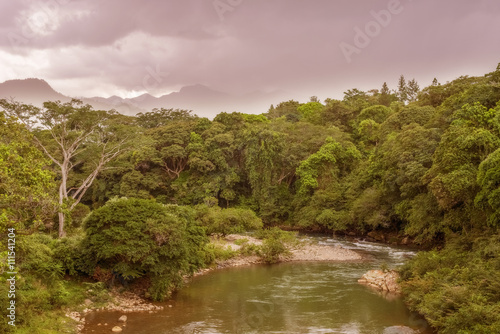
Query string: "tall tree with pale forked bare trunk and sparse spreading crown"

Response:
xmin=0 ymin=99 xmax=127 ymax=237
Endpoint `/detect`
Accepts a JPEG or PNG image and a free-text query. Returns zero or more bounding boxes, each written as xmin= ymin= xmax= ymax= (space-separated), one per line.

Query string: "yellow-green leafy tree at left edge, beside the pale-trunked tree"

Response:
xmin=0 ymin=112 xmax=57 ymax=234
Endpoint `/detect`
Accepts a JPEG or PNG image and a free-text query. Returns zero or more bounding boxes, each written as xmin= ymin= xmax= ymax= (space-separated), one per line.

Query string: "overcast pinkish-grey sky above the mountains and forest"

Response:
xmin=0 ymin=0 xmax=500 ymax=99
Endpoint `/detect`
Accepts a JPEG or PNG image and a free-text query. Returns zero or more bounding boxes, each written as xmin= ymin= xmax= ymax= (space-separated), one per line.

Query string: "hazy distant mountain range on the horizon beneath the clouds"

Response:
xmin=0 ymin=79 xmax=290 ymax=118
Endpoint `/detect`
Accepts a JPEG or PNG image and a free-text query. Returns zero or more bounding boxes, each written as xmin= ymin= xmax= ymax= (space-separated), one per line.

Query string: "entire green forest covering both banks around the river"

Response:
xmin=0 ymin=64 xmax=500 ymax=333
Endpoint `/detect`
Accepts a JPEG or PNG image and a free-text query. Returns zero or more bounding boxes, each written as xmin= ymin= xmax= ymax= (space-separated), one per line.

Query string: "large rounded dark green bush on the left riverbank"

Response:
xmin=83 ymin=198 xmax=208 ymax=300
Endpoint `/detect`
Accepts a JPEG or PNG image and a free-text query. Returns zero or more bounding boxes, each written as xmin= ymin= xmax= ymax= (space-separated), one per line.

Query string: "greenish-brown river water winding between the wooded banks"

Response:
xmin=83 ymin=236 xmax=432 ymax=334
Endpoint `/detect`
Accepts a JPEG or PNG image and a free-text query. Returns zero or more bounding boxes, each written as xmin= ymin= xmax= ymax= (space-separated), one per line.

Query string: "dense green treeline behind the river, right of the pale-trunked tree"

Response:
xmin=44 ymin=69 xmax=500 ymax=244
